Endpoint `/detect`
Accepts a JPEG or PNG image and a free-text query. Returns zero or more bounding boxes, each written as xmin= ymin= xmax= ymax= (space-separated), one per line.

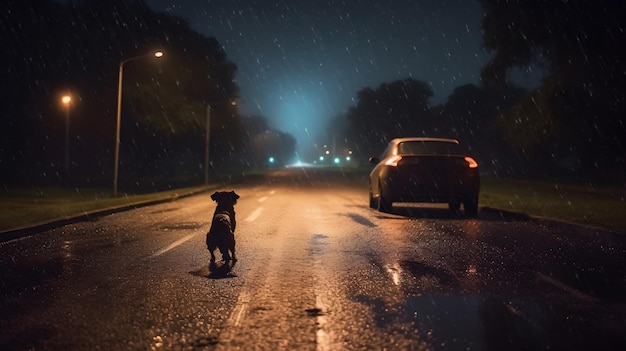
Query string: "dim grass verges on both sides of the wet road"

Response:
xmin=0 ymin=177 xmax=626 ymax=234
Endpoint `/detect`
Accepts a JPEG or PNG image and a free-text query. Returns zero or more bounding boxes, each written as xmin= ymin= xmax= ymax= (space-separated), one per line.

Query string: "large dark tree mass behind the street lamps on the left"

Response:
xmin=0 ymin=0 xmax=243 ymax=185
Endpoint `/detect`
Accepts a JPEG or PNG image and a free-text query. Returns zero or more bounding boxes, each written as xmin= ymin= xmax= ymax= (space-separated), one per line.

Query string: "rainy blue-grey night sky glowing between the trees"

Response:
xmin=147 ymin=0 xmax=523 ymax=157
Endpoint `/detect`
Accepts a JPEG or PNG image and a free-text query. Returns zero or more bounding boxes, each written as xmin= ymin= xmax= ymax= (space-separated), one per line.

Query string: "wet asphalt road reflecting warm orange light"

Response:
xmin=0 ymin=169 xmax=626 ymax=350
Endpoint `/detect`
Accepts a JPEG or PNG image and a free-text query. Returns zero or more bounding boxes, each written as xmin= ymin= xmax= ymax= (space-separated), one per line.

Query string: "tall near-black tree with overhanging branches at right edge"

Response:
xmin=481 ymin=0 xmax=626 ymax=182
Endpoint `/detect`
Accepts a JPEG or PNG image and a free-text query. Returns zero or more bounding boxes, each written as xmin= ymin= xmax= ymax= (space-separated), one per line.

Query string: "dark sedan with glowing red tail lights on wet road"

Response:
xmin=369 ymin=137 xmax=480 ymax=217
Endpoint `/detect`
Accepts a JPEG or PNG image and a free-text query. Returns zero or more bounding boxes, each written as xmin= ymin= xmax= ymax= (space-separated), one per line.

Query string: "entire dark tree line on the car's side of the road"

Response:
xmin=343 ymin=0 xmax=626 ymax=183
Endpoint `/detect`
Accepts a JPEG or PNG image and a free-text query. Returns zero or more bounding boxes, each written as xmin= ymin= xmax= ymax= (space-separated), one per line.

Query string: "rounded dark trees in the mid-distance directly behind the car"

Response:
xmin=345 ymin=79 xmax=525 ymax=174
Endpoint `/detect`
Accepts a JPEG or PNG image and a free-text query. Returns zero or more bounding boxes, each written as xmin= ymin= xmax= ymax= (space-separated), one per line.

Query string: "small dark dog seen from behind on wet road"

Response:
xmin=206 ymin=191 xmax=239 ymax=263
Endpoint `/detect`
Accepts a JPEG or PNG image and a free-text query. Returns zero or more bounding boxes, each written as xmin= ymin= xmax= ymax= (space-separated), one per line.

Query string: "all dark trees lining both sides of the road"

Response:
xmin=0 ymin=0 xmax=626 ymax=185
